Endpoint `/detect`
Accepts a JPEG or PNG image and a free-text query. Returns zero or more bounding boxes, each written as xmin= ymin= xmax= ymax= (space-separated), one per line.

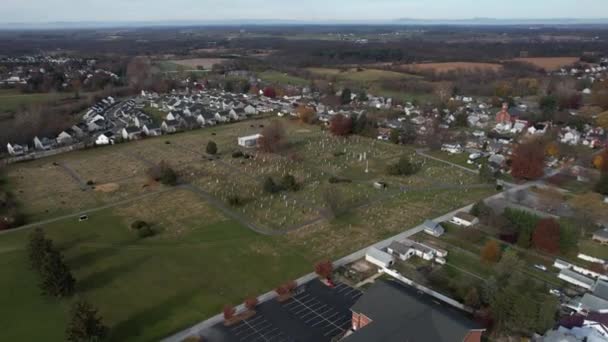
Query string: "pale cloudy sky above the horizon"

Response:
xmin=0 ymin=0 xmax=608 ymax=23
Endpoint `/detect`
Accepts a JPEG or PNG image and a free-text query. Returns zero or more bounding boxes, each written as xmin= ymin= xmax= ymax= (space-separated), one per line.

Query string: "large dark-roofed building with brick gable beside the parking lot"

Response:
xmin=344 ymin=280 xmax=485 ymax=342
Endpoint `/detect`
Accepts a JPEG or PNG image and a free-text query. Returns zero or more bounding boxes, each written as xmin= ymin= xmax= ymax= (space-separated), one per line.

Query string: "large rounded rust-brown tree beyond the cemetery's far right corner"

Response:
xmin=511 ymin=141 xmax=545 ymax=180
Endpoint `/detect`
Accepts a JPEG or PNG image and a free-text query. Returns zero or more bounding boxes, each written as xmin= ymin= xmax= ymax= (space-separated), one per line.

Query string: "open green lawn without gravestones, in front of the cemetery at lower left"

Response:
xmin=0 ymin=192 xmax=314 ymax=341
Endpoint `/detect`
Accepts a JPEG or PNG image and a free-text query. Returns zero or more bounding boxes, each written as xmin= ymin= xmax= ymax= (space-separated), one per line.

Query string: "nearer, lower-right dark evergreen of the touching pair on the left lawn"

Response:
xmin=40 ymin=249 xmax=76 ymax=297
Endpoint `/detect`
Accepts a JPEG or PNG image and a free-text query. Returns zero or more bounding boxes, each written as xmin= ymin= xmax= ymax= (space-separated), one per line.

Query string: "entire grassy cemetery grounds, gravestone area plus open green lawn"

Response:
xmin=0 ymin=119 xmax=494 ymax=341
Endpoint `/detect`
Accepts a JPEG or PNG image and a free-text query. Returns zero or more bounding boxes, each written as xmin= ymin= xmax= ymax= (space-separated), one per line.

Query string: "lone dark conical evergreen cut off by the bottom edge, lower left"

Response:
xmin=66 ymin=300 xmax=108 ymax=342
